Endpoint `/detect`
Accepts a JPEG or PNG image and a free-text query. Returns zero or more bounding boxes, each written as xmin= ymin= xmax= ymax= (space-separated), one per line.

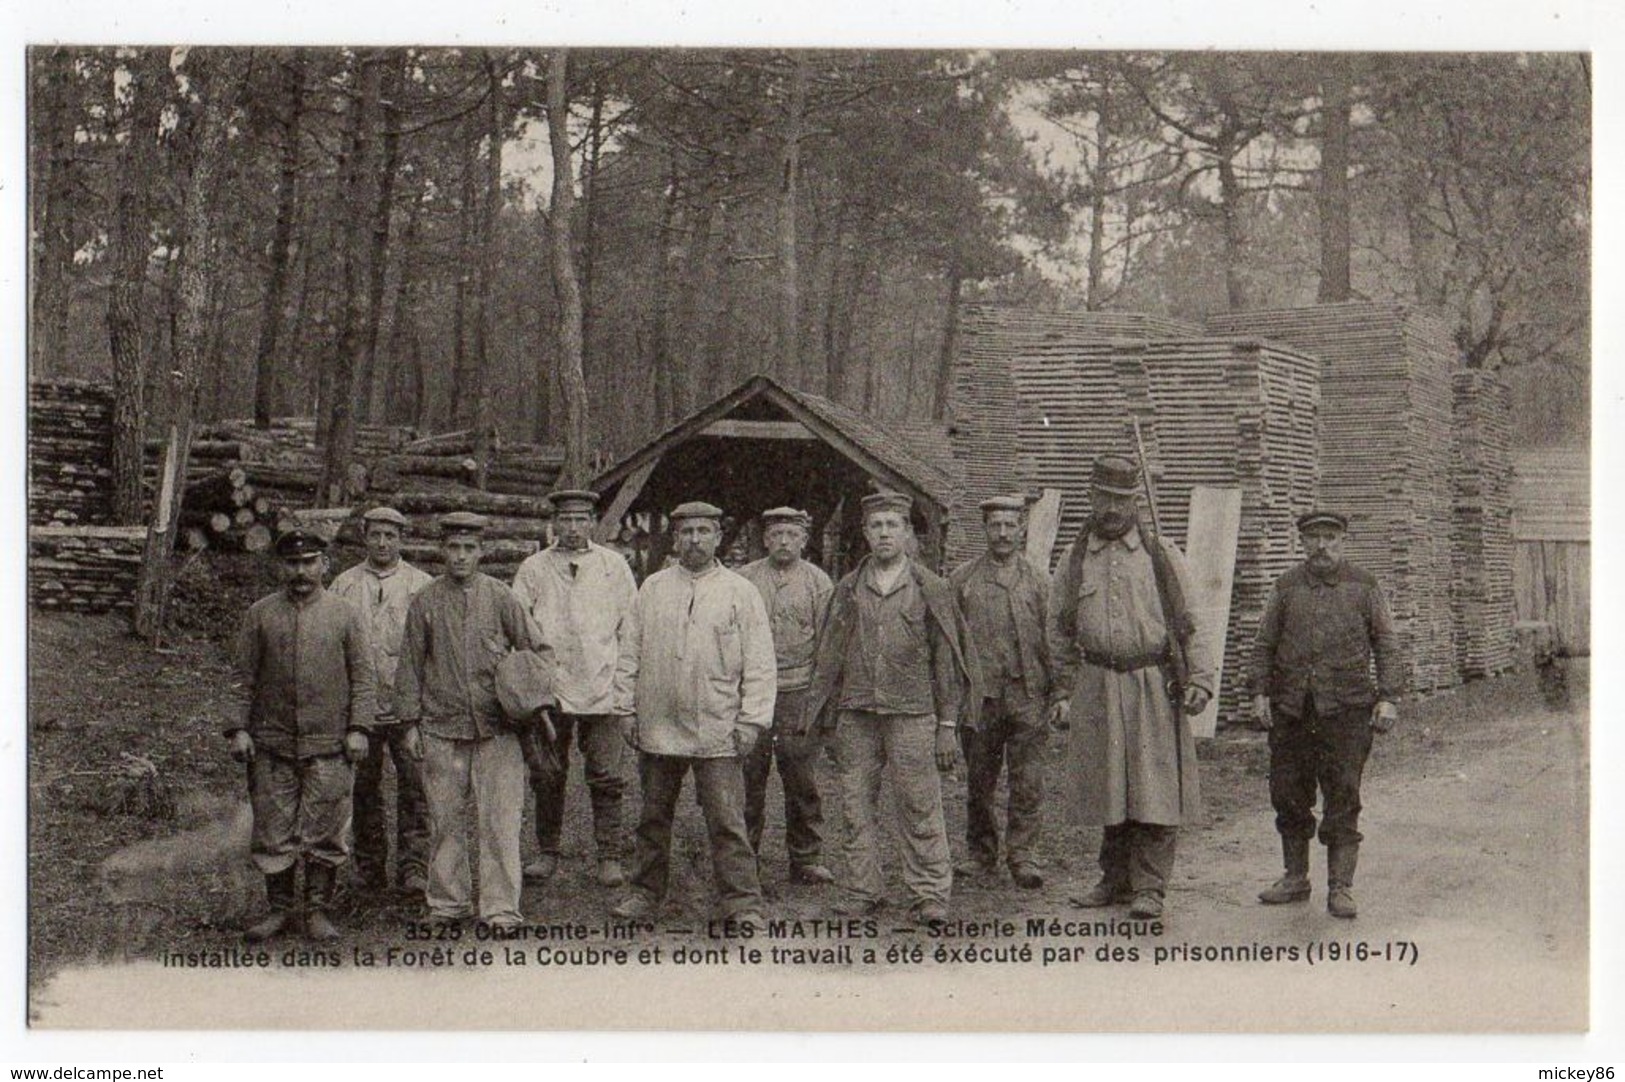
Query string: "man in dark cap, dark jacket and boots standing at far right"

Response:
xmin=1253 ymin=512 xmax=1402 ymax=918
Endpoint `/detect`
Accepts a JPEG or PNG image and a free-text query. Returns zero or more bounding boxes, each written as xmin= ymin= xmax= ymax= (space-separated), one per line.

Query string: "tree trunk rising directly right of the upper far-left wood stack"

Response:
xmin=107 ymin=50 xmax=169 ymax=525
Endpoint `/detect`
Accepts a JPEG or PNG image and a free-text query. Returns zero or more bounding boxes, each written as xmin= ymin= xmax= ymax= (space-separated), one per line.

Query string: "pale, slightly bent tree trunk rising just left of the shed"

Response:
xmin=546 ymin=49 xmax=588 ymax=484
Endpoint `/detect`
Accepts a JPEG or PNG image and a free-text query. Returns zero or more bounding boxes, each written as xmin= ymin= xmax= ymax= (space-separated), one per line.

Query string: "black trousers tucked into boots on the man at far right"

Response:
xmin=1269 ymin=695 xmax=1372 ymax=845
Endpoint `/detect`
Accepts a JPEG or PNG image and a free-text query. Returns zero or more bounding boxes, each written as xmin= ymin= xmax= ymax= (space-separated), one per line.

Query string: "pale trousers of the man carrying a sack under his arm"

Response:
xmin=423 ymin=733 xmax=525 ymax=923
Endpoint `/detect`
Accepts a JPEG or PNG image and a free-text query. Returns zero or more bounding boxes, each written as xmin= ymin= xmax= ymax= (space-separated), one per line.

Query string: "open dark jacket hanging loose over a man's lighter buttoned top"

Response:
xmin=806 ymin=556 xmax=982 ymax=729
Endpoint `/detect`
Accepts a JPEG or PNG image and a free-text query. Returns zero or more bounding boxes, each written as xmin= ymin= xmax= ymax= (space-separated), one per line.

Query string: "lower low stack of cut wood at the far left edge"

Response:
xmin=28 ymin=526 xmax=146 ymax=612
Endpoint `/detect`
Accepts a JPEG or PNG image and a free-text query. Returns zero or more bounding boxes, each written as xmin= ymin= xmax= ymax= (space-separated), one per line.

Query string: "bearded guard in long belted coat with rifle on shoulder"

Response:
xmin=1050 ymin=455 xmax=1216 ymax=920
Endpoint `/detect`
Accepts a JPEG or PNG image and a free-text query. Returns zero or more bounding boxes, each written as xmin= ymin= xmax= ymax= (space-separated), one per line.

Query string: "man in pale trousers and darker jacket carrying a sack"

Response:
xmin=395 ymin=512 xmax=540 ymax=928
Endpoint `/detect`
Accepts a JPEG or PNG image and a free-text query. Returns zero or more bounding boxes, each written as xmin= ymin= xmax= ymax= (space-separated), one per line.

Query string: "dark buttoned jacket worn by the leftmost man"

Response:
xmin=237 ymin=590 xmax=377 ymax=759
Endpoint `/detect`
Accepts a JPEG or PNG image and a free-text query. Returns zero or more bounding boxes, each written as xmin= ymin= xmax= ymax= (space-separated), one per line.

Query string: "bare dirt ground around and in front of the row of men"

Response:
xmin=29 ymin=614 xmax=1589 ymax=1032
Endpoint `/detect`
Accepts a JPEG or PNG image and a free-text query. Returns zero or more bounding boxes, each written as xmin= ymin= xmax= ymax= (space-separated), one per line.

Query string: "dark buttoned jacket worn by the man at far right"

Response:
xmin=1253 ymin=560 xmax=1404 ymax=718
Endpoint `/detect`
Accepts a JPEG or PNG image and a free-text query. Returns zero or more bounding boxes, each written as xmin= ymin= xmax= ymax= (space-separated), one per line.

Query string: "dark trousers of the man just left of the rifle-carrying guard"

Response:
xmin=960 ymin=681 xmax=1048 ymax=868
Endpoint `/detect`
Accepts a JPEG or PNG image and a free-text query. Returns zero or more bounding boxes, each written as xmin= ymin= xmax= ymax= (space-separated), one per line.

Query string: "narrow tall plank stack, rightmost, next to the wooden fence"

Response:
xmin=1451 ymin=369 xmax=1516 ymax=679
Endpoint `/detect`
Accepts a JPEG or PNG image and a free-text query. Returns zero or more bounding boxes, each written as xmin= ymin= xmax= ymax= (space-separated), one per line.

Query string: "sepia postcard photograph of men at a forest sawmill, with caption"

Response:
xmin=7 ymin=0 xmax=1614 ymax=1037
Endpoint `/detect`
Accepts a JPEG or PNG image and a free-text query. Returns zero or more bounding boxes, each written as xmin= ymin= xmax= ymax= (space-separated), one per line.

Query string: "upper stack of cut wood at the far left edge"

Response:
xmin=28 ymin=380 xmax=112 ymax=525
